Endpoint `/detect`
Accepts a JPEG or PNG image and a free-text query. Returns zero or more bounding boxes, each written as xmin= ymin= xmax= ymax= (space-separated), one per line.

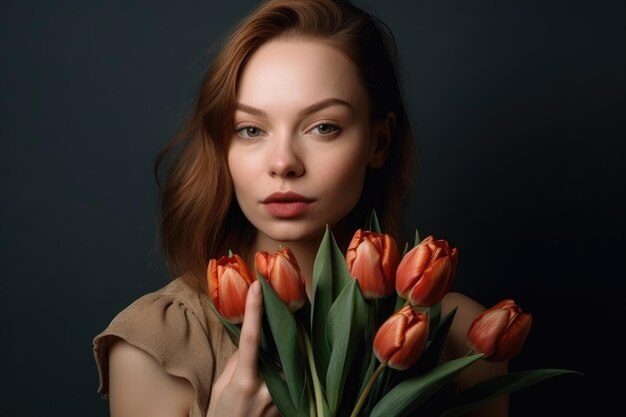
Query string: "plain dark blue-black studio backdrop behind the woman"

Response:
xmin=0 ymin=0 xmax=626 ymax=417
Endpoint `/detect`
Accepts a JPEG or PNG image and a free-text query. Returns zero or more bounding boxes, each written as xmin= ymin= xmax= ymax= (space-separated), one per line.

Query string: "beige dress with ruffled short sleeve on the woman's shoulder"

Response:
xmin=93 ymin=278 xmax=236 ymax=417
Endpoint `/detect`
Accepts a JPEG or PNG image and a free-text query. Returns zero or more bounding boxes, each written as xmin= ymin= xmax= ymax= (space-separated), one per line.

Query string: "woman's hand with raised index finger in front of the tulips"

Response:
xmin=207 ymin=281 xmax=280 ymax=417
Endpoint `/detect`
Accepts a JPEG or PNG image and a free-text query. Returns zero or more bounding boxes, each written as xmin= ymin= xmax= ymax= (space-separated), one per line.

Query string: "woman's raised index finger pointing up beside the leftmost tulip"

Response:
xmin=235 ymin=281 xmax=263 ymax=381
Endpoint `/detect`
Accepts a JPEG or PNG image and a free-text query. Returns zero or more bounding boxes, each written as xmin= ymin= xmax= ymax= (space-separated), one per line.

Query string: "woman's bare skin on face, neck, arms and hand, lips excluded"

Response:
xmin=109 ymin=37 xmax=508 ymax=417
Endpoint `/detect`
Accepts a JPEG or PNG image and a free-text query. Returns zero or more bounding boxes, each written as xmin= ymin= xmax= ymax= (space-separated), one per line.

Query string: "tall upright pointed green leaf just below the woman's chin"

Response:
xmin=311 ymin=226 xmax=353 ymax=381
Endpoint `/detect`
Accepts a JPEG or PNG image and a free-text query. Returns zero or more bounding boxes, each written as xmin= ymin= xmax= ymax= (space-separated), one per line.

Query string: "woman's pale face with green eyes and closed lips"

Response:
xmin=228 ymin=37 xmax=380 ymax=247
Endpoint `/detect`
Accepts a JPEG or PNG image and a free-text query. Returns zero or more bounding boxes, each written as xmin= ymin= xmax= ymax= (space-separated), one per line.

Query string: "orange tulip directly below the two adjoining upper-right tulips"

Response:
xmin=374 ymin=306 xmax=428 ymax=370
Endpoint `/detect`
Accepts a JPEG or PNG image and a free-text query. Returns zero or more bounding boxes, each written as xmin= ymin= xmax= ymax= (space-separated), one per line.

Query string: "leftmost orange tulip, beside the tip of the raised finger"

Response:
xmin=207 ymin=255 xmax=254 ymax=324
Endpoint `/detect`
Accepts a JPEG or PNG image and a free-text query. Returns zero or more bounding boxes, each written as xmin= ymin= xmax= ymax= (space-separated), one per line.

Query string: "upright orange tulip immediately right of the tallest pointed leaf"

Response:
xmin=346 ymin=229 xmax=400 ymax=300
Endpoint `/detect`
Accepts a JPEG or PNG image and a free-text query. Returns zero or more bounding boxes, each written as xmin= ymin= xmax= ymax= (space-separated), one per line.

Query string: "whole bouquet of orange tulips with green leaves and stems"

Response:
xmin=208 ymin=214 xmax=573 ymax=417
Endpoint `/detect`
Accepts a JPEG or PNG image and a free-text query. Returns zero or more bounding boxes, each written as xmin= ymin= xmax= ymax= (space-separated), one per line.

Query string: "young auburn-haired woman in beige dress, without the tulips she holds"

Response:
xmin=94 ymin=0 xmax=507 ymax=417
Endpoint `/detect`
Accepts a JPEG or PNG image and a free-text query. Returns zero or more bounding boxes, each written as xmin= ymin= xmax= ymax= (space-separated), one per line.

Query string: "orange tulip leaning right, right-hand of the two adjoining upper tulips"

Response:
xmin=396 ymin=236 xmax=458 ymax=307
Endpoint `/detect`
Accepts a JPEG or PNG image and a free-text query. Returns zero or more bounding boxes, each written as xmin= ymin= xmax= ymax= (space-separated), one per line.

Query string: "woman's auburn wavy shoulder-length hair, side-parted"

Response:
xmin=155 ymin=0 xmax=417 ymax=286
